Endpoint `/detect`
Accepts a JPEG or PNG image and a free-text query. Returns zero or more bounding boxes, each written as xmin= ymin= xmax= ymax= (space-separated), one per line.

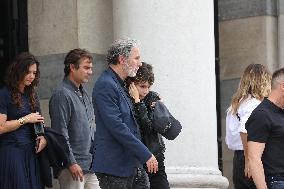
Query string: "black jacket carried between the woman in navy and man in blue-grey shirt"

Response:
xmin=39 ymin=127 xmax=71 ymax=187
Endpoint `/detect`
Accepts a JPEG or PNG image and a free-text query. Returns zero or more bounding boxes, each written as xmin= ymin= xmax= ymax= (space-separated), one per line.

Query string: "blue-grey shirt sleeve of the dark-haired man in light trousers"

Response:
xmin=49 ymin=91 xmax=76 ymax=164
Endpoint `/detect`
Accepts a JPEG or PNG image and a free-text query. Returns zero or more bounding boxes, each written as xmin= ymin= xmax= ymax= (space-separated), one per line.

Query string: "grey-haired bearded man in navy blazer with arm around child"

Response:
xmin=92 ymin=38 xmax=158 ymax=189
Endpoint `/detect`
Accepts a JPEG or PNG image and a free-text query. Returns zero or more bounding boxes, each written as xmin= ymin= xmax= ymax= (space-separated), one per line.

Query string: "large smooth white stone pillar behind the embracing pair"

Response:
xmin=113 ymin=0 xmax=228 ymax=188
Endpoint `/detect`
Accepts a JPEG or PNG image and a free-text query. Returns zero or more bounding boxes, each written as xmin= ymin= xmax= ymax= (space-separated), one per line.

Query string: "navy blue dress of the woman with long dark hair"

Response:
xmin=0 ymin=87 xmax=43 ymax=189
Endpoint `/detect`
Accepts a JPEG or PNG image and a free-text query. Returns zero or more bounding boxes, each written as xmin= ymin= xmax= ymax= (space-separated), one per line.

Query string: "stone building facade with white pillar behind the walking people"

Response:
xmin=6 ymin=0 xmax=272 ymax=188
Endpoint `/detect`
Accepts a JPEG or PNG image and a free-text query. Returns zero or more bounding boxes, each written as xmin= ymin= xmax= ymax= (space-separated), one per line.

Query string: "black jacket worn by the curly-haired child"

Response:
xmin=134 ymin=91 xmax=166 ymax=167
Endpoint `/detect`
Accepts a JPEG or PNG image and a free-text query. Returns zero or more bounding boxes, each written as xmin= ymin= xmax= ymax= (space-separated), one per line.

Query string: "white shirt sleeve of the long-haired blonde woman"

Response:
xmin=238 ymin=101 xmax=259 ymax=133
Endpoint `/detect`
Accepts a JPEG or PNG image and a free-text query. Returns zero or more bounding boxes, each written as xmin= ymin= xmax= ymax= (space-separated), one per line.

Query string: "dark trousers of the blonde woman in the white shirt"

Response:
xmin=233 ymin=150 xmax=256 ymax=189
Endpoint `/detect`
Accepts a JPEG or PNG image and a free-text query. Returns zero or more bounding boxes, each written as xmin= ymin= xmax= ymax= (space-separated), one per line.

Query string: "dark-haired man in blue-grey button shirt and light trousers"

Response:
xmin=49 ymin=49 xmax=96 ymax=189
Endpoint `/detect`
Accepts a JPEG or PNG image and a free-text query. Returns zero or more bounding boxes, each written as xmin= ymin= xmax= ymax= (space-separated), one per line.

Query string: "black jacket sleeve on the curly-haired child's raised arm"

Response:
xmin=134 ymin=102 xmax=153 ymax=133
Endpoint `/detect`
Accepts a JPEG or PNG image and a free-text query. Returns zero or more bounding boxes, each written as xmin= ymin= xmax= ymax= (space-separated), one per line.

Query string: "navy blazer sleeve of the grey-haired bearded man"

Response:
xmin=93 ymin=82 xmax=152 ymax=164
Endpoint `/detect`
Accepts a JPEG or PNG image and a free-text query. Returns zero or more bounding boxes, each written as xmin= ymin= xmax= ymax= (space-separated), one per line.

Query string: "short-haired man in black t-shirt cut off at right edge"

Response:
xmin=246 ymin=68 xmax=284 ymax=189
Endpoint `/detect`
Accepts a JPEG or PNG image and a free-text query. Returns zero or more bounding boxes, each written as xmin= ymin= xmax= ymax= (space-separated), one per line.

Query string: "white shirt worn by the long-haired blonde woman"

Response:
xmin=225 ymin=97 xmax=261 ymax=150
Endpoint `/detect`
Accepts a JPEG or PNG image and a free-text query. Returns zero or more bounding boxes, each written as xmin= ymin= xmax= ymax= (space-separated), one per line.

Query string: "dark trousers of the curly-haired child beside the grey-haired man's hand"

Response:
xmin=145 ymin=153 xmax=170 ymax=189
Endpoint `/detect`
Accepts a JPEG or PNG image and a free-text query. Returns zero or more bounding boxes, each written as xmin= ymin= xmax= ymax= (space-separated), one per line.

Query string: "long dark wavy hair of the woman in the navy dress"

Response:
xmin=5 ymin=52 xmax=40 ymax=112
